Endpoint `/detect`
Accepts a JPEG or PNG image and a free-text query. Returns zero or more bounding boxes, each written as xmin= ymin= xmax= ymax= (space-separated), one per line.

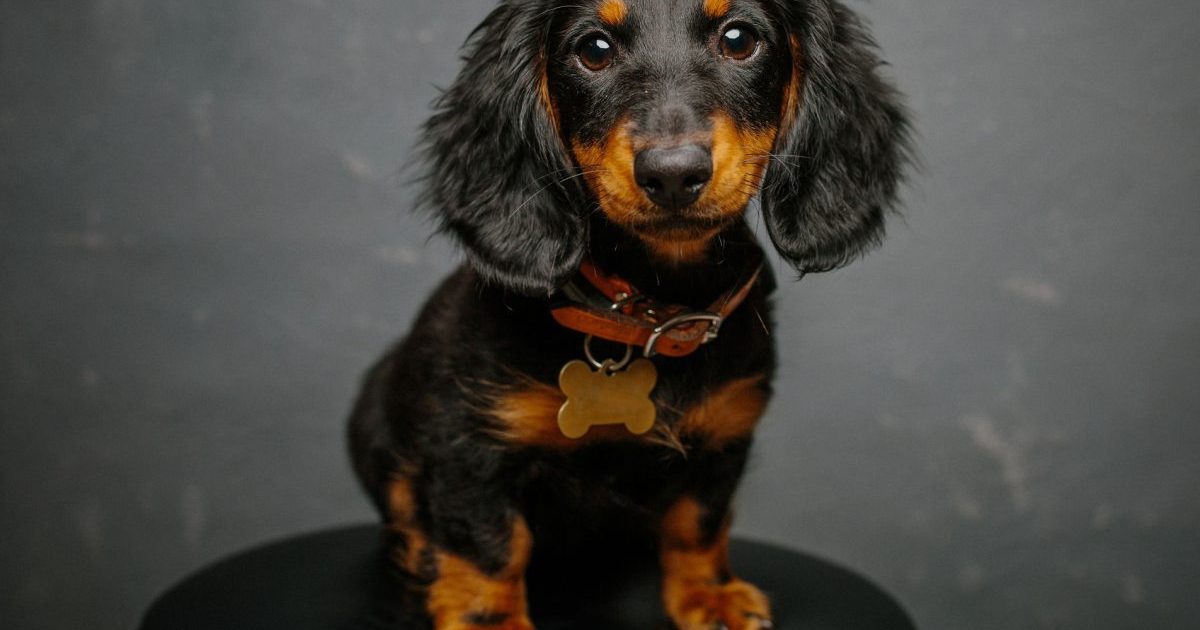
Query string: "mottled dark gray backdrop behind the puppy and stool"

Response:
xmin=0 ymin=0 xmax=1200 ymax=630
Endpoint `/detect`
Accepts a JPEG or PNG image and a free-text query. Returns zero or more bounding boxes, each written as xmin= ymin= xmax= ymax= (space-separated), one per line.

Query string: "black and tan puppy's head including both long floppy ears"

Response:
xmin=424 ymin=0 xmax=907 ymax=294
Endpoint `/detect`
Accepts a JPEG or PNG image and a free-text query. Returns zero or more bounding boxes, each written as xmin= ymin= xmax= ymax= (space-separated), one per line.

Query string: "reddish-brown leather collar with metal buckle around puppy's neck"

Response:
xmin=551 ymin=254 xmax=762 ymax=356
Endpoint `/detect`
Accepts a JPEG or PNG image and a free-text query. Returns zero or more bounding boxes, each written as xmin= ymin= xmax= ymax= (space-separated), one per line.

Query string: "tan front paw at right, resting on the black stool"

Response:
xmin=665 ymin=580 xmax=773 ymax=630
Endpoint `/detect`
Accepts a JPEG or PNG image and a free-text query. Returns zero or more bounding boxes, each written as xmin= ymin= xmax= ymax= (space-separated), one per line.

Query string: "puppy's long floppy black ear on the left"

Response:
xmin=421 ymin=0 xmax=584 ymax=295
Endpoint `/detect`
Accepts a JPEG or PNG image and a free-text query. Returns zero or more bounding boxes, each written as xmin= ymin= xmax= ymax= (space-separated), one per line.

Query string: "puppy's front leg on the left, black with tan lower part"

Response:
xmin=389 ymin=468 xmax=533 ymax=630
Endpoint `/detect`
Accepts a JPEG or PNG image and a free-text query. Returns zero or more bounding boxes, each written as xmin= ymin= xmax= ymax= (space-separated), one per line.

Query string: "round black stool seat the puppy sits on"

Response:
xmin=142 ymin=526 xmax=914 ymax=630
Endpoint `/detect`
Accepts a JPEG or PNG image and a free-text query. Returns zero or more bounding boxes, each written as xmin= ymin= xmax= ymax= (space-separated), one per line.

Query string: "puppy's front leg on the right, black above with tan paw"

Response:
xmin=659 ymin=446 xmax=772 ymax=630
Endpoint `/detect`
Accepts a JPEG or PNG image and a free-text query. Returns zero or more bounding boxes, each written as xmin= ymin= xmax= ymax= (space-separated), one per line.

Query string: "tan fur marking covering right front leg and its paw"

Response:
xmin=660 ymin=498 xmax=770 ymax=630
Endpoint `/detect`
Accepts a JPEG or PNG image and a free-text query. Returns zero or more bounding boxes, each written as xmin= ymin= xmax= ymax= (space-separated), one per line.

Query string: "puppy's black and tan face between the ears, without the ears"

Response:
xmin=545 ymin=0 xmax=798 ymax=259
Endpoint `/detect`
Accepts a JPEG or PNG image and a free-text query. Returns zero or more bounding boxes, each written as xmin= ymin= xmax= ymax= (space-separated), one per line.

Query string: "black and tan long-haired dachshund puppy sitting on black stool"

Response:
xmin=349 ymin=0 xmax=910 ymax=630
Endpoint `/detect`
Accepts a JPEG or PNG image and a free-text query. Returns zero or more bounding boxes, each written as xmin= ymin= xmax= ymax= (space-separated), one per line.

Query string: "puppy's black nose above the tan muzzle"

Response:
xmin=634 ymin=144 xmax=713 ymax=208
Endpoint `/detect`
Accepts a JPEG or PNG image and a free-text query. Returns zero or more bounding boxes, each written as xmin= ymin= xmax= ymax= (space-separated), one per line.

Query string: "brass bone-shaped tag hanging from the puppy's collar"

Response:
xmin=558 ymin=359 xmax=659 ymax=439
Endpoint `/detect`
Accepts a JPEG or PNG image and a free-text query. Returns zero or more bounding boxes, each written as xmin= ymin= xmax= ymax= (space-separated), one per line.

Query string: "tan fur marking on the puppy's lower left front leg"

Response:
xmin=427 ymin=517 xmax=533 ymax=630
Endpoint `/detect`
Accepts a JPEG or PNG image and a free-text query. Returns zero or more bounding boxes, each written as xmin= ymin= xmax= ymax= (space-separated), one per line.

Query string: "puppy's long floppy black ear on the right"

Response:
xmin=762 ymin=0 xmax=910 ymax=274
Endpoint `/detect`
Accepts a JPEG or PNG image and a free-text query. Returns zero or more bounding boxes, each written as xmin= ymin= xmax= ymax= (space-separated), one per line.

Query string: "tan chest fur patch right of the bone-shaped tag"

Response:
xmin=678 ymin=376 xmax=767 ymax=445
